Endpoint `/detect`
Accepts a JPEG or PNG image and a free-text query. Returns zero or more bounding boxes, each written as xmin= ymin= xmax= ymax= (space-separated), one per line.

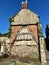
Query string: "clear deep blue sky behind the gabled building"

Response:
xmin=0 ymin=0 xmax=49 ymax=36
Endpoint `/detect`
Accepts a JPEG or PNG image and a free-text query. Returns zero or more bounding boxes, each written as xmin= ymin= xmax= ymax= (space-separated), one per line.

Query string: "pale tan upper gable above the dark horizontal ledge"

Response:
xmin=11 ymin=9 xmax=39 ymax=25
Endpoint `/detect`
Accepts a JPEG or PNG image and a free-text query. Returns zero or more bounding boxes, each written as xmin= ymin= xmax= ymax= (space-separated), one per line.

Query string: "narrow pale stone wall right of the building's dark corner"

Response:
xmin=39 ymin=37 xmax=47 ymax=65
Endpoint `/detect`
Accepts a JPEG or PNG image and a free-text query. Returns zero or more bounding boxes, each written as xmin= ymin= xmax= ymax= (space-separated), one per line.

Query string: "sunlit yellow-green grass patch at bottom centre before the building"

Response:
xmin=15 ymin=58 xmax=40 ymax=65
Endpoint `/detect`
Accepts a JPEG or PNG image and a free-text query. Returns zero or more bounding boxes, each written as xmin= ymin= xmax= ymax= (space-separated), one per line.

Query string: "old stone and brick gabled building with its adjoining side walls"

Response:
xmin=0 ymin=1 xmax=46 ymax=65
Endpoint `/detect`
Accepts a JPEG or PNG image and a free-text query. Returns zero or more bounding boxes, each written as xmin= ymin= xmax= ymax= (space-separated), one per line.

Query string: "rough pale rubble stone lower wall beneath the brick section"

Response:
xmin=11 ymin=41 xmax=39 ymax=59
